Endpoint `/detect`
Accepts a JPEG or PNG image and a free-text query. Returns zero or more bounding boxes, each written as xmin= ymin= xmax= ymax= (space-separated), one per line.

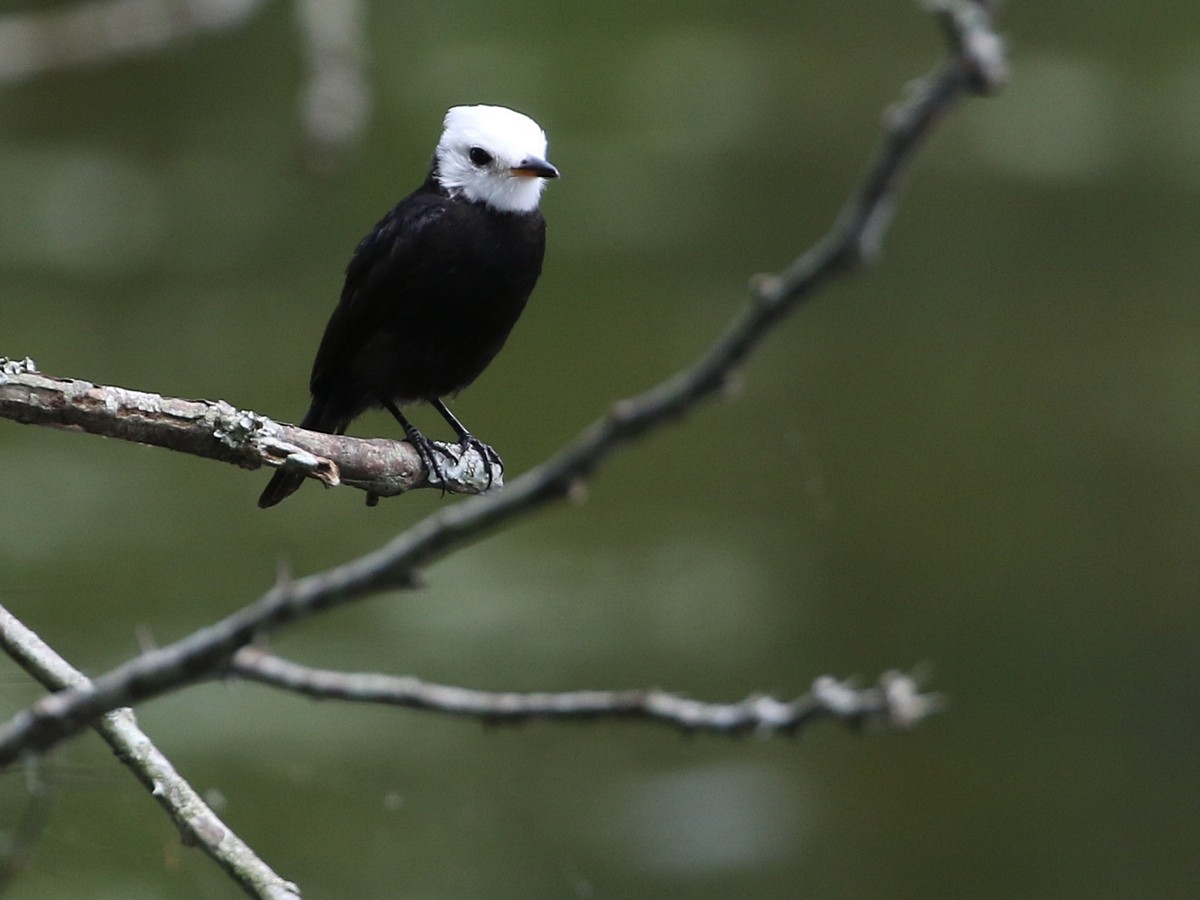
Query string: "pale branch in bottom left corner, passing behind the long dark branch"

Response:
xmin=0 ymin=606 xmax=300 ymax=900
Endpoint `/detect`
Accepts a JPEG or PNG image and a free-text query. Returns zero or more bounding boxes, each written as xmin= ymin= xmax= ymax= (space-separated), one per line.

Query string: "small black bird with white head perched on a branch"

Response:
xmin=258 ymin=106 xmax=558 ymax=509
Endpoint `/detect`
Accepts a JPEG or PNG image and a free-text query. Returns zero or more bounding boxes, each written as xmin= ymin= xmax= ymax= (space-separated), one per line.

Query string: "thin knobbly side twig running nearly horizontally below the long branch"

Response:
xmin=228 ymin=647 xmax=942 ymax=734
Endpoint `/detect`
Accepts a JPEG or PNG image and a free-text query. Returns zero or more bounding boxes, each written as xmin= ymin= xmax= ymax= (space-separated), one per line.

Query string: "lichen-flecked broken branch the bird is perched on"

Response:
xmin=0 ymin=358 xmax=503 ymax=497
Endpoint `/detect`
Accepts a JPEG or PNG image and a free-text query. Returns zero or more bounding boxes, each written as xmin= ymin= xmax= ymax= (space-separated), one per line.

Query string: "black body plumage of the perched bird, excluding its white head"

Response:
xmin=258 ymin=162 xmax=557 ymax=508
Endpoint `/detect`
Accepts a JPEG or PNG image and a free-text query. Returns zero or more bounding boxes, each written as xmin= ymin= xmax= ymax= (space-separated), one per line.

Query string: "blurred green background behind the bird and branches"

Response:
xmin=0 ymin=0 xmax=1200 ymax=900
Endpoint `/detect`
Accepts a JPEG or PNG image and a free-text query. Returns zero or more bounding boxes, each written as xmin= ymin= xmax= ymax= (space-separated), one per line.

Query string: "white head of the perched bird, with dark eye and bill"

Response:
xmin=436 ymin=107 xmax=558 ymax=212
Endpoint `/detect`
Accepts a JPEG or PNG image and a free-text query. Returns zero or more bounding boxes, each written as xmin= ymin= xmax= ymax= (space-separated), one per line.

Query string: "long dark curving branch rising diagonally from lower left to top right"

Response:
xmin=0 ymin=0 xmax=1004 ymax=766
